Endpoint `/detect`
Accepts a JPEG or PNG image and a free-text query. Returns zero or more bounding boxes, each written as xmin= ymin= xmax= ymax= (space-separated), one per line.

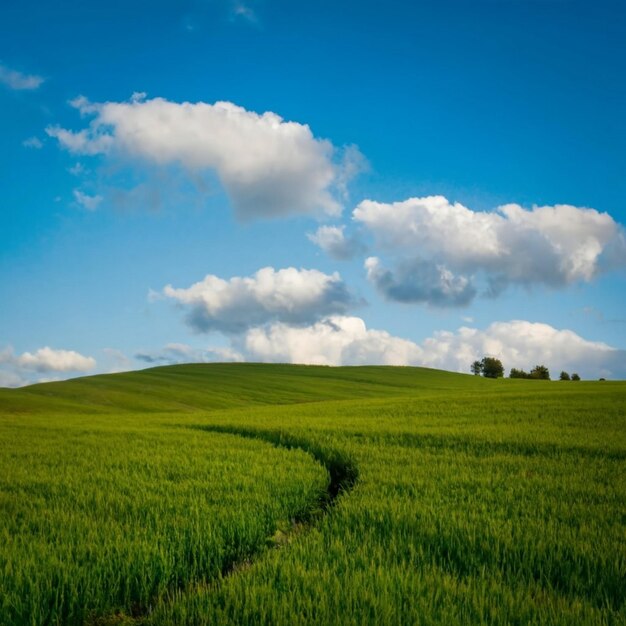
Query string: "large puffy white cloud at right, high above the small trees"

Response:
xmin=353 ymin=196 xmax=626 ymax=304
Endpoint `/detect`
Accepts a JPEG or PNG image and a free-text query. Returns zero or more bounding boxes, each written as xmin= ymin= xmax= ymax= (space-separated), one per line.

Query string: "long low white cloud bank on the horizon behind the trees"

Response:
xmin=241 ymin=316 xmax=626 ymax=378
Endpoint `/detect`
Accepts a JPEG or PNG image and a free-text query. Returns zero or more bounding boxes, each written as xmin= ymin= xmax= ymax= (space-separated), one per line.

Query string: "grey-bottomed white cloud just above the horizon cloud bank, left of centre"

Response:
xmin=163 ymin=267 xmax=354 ymax=332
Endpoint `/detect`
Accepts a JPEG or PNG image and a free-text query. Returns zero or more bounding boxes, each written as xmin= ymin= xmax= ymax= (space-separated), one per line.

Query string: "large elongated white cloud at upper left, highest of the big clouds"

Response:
xmin=46 ymin=94 xmax=358 ymax=219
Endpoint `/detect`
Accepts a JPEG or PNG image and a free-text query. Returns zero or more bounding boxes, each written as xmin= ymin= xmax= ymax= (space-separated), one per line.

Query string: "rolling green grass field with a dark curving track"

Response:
xmin=0 ymin=364 xmax=626 ymax=626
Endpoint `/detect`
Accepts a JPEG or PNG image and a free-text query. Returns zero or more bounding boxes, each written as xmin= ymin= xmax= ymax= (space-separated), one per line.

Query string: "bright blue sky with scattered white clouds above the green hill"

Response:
xmin=0 ymin=0 xmax=626 ymax=385
